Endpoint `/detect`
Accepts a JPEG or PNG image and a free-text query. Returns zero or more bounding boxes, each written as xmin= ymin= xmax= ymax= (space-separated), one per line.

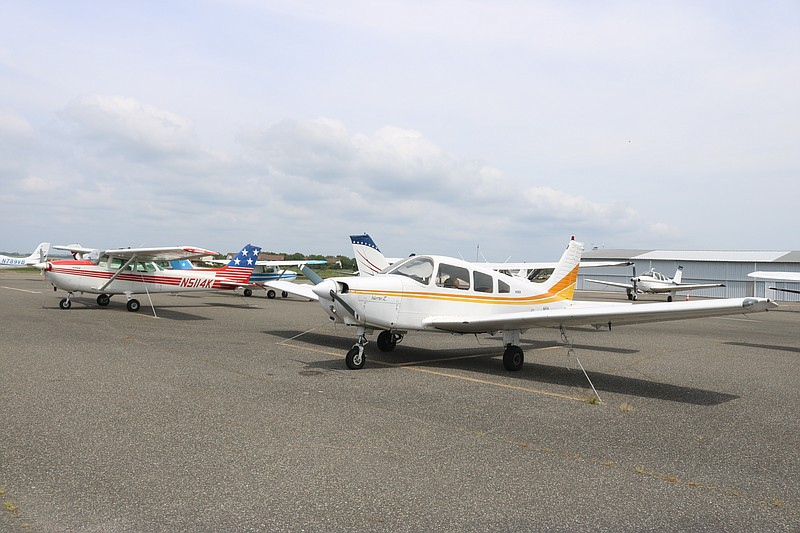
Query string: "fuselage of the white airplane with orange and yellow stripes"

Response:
xmin=314 ymin=256 xmax=577 ymax=331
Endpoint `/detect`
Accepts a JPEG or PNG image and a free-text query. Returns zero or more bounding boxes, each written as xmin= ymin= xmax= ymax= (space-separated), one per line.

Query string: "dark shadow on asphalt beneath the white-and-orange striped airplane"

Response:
xmin=270 ymin=331 xmax=739 ymax=406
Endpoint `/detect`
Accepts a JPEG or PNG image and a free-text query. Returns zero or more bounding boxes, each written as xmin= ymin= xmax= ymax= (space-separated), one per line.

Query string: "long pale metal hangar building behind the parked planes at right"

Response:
xmin=577 ymin=248 xmax=800 ymax=301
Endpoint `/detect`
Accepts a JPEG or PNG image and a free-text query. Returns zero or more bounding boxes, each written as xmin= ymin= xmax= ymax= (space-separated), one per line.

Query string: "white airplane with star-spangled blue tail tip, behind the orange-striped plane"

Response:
xmin=350 ymin=233 xmax=633 ymax=281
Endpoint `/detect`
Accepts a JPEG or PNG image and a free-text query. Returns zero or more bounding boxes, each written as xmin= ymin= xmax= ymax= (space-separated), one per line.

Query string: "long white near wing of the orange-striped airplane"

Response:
xmin=422 ymin=298 xmax=777 ymax=333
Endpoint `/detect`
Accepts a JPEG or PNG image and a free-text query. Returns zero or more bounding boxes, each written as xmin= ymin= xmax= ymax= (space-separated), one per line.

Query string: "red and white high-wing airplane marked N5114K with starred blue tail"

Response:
xmin=44 ymin=244 xmax=261 ymax=311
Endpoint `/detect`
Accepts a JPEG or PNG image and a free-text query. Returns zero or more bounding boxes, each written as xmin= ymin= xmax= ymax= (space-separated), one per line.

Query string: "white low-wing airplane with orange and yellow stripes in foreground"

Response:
xmin=306 ymin=240 xmax=777 ymax=370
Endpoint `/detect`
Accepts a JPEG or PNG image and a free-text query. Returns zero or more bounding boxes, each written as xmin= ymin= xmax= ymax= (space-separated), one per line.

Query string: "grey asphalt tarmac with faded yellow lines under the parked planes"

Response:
xmin=0 ymin=272 xmax=800 ymax=532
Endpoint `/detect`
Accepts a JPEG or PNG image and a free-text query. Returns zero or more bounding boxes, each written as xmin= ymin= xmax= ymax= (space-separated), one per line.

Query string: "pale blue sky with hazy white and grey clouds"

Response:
xmin=0 ymin=0 xmax=800 ymax=261
